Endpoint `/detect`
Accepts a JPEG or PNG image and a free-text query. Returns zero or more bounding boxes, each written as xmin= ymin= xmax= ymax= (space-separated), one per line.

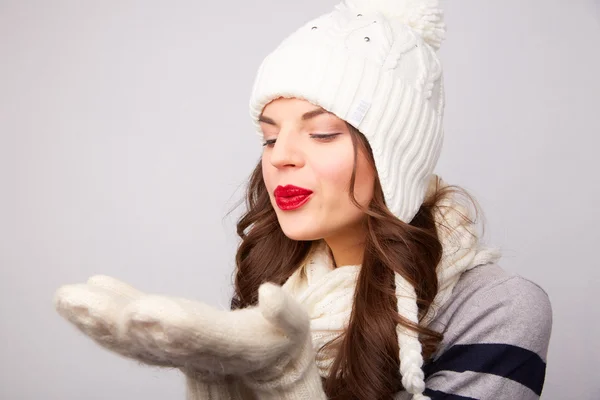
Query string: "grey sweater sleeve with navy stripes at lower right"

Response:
xmin=423 ymin=276 xmax=552 ymax=400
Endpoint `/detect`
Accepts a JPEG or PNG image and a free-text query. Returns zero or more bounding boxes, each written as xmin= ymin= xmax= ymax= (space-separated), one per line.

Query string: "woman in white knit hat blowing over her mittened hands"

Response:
xmin=56 ymin=0 xmax=551 ymax=400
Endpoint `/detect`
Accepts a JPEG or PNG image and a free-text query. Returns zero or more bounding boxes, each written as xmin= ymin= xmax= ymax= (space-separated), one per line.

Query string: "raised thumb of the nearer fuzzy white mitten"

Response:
xmin=258 ymin=282 xmax=309 ymax=340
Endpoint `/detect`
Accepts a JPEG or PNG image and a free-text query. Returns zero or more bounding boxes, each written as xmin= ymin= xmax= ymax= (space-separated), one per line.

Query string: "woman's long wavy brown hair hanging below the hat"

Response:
xmin=231 ymin=125 xmax=479 ymax=400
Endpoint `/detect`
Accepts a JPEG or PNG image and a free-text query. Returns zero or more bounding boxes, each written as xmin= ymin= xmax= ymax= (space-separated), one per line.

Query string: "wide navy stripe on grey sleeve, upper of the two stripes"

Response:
xmin=423 ymin=343 xmax=546 ymax=396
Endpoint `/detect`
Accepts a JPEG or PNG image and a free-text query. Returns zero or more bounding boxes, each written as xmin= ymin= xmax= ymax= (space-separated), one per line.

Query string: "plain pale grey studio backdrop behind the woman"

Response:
xmin=0 ymin=0 xmax=600 ymax=400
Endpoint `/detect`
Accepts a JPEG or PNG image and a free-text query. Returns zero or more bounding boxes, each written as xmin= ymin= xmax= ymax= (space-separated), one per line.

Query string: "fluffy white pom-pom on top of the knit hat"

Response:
xmin=342 ymin=0 xmax=446 ymax=50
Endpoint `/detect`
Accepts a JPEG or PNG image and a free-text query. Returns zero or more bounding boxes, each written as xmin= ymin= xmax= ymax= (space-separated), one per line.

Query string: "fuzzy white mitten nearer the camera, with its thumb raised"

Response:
xmin=117 ymin=283 xmax=327 ymax=400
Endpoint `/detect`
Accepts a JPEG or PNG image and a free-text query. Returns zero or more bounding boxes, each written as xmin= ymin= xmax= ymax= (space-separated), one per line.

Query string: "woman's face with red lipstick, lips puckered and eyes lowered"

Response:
xmin=260 ymin=98 xmax=375 ymax=244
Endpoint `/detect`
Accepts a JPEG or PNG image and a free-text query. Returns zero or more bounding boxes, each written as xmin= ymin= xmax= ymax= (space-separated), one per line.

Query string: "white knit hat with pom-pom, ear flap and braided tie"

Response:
xmin=250 ymin=0 xmax=445 ymax=399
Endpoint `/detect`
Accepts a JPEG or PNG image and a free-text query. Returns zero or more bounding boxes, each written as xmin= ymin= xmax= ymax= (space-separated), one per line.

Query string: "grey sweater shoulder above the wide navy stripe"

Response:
xmin=432 ymin=264 xmax=552 ymax=359
